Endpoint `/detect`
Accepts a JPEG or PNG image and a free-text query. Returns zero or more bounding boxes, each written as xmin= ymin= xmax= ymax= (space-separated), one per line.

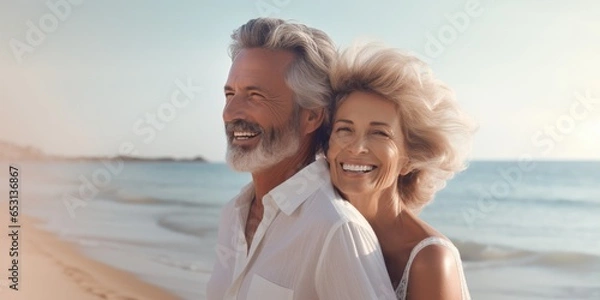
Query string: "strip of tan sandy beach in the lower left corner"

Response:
xmin=0 ymin=215 xmax=179 ymax=300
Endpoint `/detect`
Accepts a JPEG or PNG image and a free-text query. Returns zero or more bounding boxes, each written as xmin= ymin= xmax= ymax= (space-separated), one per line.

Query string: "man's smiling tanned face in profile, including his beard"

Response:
xmin=223 ymin=48 xmax=300 ymax=172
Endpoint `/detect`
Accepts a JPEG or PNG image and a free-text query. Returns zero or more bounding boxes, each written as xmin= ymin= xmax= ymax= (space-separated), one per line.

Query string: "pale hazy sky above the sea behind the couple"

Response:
xmin=0 ymin=0 xmax=600 ymax=161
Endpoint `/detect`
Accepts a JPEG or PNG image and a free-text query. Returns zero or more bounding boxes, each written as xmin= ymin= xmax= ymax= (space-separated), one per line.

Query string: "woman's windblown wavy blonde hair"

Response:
xmin=330 ymin=43 xmax=476 ymax=213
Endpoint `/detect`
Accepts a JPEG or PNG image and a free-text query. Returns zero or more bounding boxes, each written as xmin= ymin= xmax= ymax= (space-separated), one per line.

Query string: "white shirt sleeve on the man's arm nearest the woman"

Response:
xmin=315 ymin=221 xmax=396 ymax=300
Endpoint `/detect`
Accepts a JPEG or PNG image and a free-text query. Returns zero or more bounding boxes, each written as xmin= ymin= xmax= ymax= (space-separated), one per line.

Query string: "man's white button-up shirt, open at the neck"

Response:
xmin=207 ymin=159 xmax=395 ymax=300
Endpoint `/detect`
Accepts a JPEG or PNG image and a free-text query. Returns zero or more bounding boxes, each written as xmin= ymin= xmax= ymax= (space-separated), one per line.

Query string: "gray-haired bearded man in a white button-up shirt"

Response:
xmin=207 ymin=18 xmax=395 ymax=300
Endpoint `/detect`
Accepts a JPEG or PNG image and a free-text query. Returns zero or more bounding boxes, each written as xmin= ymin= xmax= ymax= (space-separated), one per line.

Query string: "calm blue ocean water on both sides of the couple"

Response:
xmin=10 ymin=161 xmax=600 ymax=299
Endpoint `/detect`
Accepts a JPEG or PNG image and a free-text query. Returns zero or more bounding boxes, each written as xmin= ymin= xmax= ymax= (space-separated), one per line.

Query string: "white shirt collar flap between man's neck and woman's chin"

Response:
xmin=265 ymin=157 xmax=329 ymax=216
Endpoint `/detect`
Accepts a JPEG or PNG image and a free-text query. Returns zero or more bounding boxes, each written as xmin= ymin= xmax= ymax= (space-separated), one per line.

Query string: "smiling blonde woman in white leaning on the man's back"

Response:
xmin=326 ymin=45 xmax=473 ymax=299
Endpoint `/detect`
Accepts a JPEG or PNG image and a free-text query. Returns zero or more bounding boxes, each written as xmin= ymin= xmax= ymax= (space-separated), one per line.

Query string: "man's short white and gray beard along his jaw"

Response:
xmin=227 ymin=122 xmax=300 ymax=173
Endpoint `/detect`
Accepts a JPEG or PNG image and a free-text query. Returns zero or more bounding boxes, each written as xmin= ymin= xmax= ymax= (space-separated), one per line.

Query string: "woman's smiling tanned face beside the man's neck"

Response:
xmin=327 ymin=91 xmax=408 ymax=198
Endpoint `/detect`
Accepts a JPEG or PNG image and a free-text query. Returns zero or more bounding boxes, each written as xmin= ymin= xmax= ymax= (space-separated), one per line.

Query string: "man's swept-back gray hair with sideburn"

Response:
xmin=229 ymin=18 xmax=336 ymax=152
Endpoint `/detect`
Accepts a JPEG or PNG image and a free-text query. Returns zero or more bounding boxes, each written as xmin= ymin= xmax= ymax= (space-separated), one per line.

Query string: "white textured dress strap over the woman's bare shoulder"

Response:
xmin=396 ymin=236 xmax=471 ymax=300
